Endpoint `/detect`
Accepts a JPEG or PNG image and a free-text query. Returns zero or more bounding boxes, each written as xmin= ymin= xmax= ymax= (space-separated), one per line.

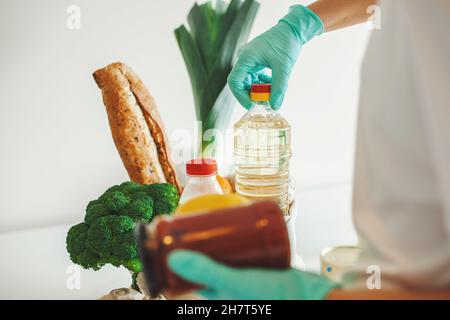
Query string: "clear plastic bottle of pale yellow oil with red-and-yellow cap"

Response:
xmin=234 ymin=84 xmax=291 ymax=215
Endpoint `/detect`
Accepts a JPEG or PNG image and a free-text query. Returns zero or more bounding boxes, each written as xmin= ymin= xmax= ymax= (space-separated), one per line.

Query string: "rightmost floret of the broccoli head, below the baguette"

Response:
xmin=144 ymin=183 xmax=180 ymax=215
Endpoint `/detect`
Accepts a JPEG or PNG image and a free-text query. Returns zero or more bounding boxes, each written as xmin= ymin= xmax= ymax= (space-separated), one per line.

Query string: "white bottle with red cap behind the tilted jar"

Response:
xmin=180 ymin=159 xmax=223 ymax=204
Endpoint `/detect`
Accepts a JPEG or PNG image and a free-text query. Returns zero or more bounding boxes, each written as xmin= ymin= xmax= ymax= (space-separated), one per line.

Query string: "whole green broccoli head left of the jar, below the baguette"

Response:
xmin=66 ymin=181 xmax=179 ymax=291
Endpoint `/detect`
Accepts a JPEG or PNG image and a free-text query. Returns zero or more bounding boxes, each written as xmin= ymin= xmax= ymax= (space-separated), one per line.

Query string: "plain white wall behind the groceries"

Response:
xmin=0 ymin=0 xmax=369 ymax=231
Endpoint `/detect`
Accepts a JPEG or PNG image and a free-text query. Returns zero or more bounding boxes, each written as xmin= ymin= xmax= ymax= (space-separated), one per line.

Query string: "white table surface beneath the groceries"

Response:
xmin=0 ymin=183 xmax=356 ymax=299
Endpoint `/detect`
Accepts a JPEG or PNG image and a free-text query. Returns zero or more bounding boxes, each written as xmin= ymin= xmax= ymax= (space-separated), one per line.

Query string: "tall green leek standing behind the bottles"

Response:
xmin=175 ymin=0 xmax=259 ymax=157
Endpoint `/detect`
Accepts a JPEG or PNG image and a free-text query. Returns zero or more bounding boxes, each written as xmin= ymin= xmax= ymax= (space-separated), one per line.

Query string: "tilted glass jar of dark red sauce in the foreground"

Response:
xmin=138 ymin=201 xmax=290 ymax=296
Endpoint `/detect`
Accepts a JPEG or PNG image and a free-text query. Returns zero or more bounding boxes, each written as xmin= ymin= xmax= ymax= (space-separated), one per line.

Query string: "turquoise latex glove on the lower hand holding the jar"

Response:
xmin=168 ymin=250 xmax=337 ymax=300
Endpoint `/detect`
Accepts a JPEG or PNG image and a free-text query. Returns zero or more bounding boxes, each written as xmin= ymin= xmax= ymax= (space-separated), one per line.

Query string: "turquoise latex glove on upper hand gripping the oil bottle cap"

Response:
xmin=228 ymin=5 xmax=324 ymax=110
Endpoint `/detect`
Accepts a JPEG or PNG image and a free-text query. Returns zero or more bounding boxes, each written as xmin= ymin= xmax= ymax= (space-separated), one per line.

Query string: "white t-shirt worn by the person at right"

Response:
xmin=353 ymin=0 xmax=450 ymax=287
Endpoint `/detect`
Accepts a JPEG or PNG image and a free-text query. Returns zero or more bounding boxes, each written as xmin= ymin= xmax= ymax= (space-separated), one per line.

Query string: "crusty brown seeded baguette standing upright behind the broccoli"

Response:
xmin=94 ymin=62 xmax=181 ymax=193
